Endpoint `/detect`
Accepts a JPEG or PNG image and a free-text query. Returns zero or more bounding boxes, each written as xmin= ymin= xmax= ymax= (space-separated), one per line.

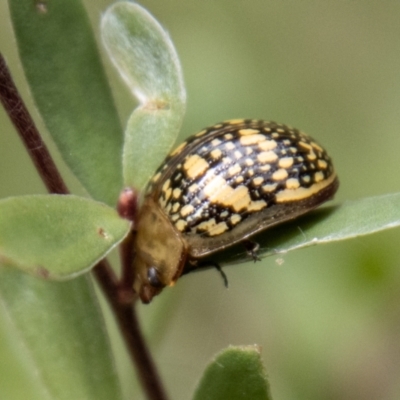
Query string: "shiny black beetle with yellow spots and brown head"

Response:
xmin=134 ymin=119 xmax=339 ymax=303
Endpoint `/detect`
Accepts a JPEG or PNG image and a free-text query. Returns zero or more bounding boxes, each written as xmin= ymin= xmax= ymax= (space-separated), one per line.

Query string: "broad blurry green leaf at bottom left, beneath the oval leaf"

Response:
xmin=0 ymin=267 xmax=122 ymax=400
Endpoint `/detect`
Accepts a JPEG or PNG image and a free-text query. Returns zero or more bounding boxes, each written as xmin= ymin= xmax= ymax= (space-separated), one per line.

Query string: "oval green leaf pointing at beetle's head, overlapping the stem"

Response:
xmin=0 ymin=195 xmax=130 ymax=279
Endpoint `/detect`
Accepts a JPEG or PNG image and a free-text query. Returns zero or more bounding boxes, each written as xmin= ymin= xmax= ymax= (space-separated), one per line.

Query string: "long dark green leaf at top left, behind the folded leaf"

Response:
xmin=9 ymin=0 xmax=122 ymax=205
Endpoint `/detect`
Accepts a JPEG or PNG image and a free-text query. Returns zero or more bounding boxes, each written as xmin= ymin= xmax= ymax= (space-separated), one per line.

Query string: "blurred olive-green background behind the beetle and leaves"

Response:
xmin=0 ymin=0 xmax=400 ymax=400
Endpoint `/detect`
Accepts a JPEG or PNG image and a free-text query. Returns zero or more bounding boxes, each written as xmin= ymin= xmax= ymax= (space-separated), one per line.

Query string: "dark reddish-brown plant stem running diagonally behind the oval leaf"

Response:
xmin=0 ymin=53 xmax=167 ymax=400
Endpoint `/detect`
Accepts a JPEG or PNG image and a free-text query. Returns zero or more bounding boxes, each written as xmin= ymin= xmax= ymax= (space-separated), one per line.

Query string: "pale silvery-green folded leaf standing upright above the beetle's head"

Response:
xmin=102 ymin=2 xmax=186 ymax=189
